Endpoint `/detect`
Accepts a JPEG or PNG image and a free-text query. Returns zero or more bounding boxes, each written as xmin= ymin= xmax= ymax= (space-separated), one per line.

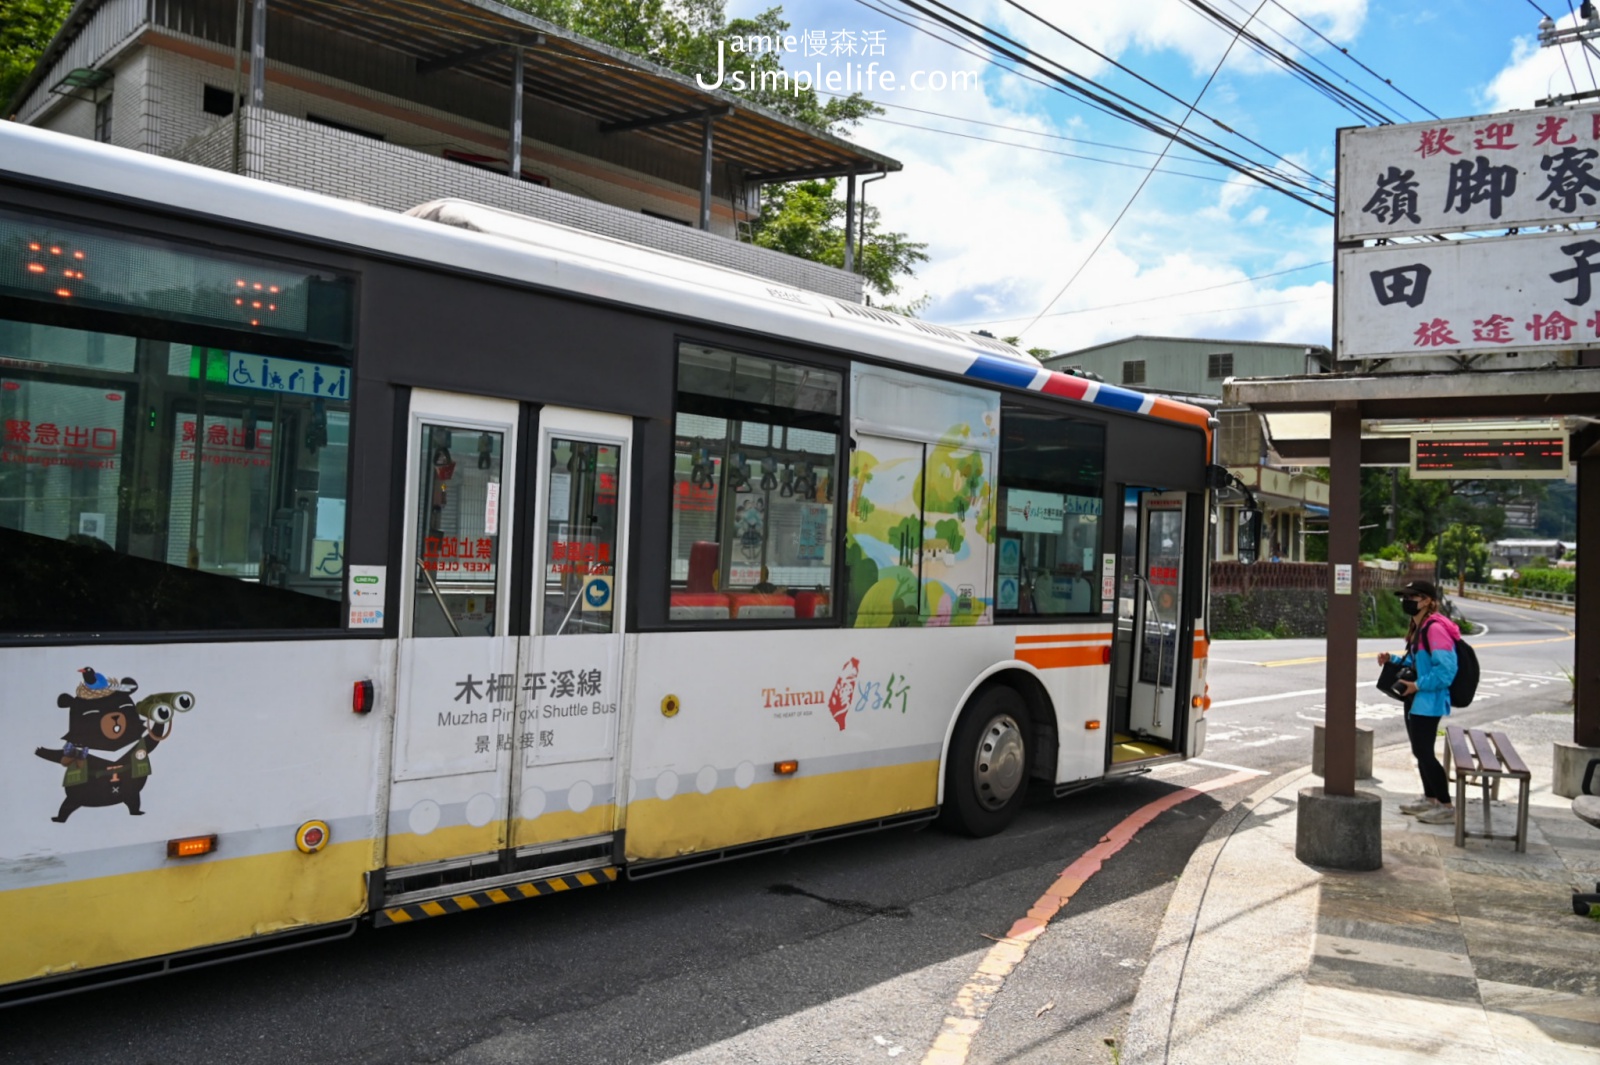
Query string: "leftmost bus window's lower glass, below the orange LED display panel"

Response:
xmin=0 ymin=320 xmax=350 ymax=635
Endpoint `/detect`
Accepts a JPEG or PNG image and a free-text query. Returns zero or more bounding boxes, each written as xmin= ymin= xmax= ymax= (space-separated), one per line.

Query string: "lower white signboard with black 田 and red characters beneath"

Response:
xmin=1334 ymin=230 xmax=1600 ymax=360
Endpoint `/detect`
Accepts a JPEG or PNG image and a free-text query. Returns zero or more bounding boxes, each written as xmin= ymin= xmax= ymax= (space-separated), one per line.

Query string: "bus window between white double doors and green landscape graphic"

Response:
xmin=670 ymin=344 xmax=843 ymax=622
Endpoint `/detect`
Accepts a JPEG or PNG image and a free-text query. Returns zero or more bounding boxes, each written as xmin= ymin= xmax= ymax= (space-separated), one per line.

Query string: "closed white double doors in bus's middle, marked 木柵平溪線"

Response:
xmin=379 ymin=390 xmax=632 ymax=923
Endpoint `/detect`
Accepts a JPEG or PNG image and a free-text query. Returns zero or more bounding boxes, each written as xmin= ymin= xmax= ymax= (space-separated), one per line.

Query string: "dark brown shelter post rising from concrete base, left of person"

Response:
xmin=1323 ymin=403 xmax=1362 ymax=795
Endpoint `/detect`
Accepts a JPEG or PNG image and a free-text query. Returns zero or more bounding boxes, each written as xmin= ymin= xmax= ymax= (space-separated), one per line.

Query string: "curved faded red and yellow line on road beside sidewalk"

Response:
xmin=922 ymin=769 xmax=1261 ymax=1065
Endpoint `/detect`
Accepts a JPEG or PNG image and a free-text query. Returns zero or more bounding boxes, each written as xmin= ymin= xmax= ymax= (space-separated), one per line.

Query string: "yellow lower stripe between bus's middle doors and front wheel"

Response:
xmin=626 ymin=760 xmax=939 ymax=862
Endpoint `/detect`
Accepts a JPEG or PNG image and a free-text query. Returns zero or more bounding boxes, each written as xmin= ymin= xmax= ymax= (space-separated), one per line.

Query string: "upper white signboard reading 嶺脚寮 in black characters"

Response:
xmin=1338 ymin=106 xmax=1600 ymax=241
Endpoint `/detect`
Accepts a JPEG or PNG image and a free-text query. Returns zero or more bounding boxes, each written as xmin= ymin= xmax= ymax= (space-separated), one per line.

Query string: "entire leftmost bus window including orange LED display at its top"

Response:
xmin=0 ymin=213 xmax=350 ymax=633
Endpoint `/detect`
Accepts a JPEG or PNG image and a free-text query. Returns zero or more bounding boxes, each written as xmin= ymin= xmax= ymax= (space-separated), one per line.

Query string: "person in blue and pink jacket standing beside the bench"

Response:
xmin=1378 ymin=580 xmax=1461 ymax=825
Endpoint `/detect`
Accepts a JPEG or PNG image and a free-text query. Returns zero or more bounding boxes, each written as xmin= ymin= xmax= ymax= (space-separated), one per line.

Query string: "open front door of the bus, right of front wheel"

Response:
xmin=1107 ymin=488 xmax=1192 ymax=771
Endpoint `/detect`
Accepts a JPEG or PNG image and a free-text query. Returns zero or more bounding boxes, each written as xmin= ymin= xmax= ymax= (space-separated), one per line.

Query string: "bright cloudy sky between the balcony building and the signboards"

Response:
xmin=732 ymin=0 xmax=1366 ymax=350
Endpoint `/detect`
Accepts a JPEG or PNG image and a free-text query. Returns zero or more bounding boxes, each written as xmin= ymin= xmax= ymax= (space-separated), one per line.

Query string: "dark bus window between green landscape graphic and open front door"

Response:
xmin=995 ymin=403 xmax=1106 ymax=617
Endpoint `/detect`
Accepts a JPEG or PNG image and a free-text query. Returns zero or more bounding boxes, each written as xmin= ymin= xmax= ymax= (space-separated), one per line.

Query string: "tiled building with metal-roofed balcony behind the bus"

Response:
xmin=8 ymin=0 xmax=901 ymax=302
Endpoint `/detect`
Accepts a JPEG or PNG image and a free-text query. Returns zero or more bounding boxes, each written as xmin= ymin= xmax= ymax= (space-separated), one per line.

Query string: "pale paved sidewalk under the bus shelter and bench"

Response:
xmin=1122 ymin=715 xmax=1600 ymax=1065
